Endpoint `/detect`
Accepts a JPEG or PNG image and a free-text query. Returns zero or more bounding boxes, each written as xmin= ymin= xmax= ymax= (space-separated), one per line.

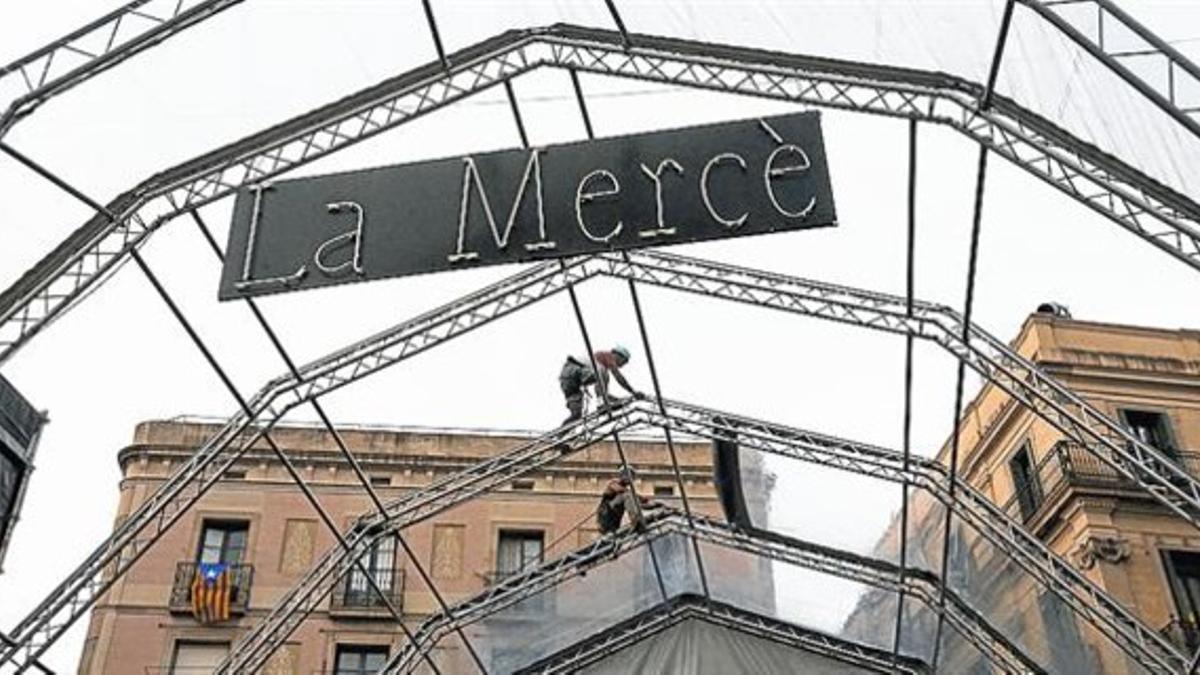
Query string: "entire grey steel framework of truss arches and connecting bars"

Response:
xmin=0 ymin=0 xmax=1200 ymax=673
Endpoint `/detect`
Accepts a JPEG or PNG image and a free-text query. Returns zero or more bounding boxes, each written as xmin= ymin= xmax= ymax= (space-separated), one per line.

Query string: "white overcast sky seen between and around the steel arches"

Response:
xmin=0 ymin=0 xmax=1200 ymax=670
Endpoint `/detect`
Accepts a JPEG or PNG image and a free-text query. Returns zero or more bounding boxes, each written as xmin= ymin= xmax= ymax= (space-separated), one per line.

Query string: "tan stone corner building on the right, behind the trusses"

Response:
xmin=846 ymin=307 xmax=1200 ymax=673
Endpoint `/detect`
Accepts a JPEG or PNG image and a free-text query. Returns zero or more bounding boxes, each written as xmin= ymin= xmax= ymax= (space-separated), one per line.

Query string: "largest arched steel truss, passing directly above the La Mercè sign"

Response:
xmin=0 ymin=26 xmax=1200 ymax=362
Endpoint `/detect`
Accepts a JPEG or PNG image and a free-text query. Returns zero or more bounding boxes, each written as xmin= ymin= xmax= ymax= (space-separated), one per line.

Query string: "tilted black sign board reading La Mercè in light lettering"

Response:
xmin=220 ymin=112 xmax=836 ymax=299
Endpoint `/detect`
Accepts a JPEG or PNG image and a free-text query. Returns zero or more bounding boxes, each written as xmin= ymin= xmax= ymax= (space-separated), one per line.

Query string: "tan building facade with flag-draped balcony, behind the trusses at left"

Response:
xmin=79 ymin=419 xmax=734 ymax=675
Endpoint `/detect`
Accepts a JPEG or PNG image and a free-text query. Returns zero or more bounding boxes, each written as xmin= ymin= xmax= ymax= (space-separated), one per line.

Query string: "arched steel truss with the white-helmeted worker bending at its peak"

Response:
xmin=231 ymin=401 xmax=1187 ymax=674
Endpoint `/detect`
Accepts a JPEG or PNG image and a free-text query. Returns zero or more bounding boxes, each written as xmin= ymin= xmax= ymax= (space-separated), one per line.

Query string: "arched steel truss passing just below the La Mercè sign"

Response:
xmin=7 ymin=251 xmax=1200 ymax=664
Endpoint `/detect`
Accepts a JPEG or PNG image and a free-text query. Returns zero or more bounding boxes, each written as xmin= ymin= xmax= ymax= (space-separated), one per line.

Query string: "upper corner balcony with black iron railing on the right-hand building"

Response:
xmin=1002 ymin=441 xmax=1200 ymax=533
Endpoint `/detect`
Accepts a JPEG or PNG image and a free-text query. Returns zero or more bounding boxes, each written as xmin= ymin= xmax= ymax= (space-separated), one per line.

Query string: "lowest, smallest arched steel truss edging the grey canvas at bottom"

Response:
xmin=517 ymin=593 xmax=930 ymax=675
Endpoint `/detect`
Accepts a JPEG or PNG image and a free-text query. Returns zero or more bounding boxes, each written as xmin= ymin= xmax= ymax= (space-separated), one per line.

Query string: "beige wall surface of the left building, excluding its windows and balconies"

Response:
xmin=79 ymin=422 xmax=724 ymax=675
